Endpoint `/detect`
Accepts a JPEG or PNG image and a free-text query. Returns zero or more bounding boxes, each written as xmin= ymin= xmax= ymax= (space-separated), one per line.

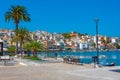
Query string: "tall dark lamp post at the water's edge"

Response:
xmin=95 ymin=18 xmax=99 ymax=64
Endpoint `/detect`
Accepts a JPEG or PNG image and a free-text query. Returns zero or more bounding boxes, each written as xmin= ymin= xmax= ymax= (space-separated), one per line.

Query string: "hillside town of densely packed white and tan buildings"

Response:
xmin=0 ymin=29 xmax=120 ymax=51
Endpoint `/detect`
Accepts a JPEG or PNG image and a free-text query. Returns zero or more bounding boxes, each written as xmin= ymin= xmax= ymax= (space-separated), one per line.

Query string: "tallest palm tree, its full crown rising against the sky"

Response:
xmin=5 ymin=5 xmax=30 ymax=54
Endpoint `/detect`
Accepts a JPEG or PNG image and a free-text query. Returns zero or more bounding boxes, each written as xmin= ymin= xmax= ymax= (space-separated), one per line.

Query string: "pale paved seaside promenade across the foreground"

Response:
xmin=0 ymin=58 xmax=120 ymax=80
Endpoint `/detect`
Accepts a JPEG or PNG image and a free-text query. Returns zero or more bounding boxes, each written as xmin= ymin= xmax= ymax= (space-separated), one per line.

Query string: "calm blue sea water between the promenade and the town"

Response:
xmin=40 ymin=51 xmax=120 ymax=66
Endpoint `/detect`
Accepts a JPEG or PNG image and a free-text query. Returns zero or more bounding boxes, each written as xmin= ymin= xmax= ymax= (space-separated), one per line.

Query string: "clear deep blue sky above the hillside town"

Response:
xmin=0 ymin=0 xmax=120 ymax=37
